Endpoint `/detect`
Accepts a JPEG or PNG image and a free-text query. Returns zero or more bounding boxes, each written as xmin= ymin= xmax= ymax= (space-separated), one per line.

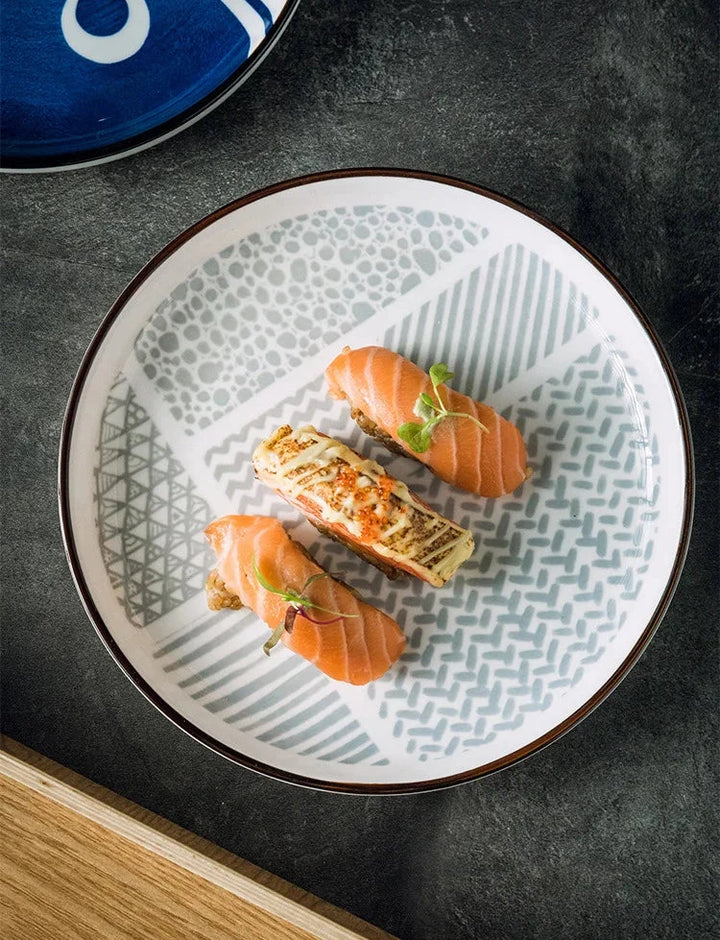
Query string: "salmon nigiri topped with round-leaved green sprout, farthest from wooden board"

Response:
xmin=325 ymin=346 xmax=530 ymax=496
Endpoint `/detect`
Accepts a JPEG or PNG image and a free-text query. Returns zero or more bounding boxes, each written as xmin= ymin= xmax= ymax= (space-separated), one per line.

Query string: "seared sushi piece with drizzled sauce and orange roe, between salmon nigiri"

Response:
xmin=253 ymin=425 xmax=475 ymax=587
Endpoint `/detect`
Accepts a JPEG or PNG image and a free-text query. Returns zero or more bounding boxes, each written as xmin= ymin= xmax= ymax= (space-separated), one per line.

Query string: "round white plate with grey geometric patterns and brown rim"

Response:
xmin=60 ymin=171 xmax=692 ymax=792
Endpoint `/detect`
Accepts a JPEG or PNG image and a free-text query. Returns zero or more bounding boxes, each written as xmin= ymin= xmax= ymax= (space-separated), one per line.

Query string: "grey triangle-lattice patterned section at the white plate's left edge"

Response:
xmin=95 ymin=375 xmax=211 ymax=626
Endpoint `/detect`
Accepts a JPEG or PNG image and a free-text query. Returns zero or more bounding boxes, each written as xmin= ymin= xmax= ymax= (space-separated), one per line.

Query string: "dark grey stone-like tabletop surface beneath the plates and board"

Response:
xmin=0 ymin=0 xmax=720 ymax=940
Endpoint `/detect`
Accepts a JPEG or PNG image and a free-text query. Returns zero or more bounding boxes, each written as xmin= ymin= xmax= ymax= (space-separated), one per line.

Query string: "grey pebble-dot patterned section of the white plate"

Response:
xmin=135 ymin=205 xmax=488 ymax=434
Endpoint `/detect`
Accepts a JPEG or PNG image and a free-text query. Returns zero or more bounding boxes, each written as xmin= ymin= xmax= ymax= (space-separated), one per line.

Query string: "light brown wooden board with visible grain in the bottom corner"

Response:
xmin=0 ymin=738 xmax=393 ymax=940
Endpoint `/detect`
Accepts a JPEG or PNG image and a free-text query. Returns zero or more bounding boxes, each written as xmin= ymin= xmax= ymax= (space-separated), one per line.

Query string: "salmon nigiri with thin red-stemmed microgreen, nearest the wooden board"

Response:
xmin=205 ymin=515 xmax=405 ymax=685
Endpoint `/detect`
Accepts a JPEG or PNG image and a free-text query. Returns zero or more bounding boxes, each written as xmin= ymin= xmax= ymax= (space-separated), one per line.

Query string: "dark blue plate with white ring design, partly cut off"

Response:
xmin=0 ymin=0 xmax=298 ymax=170
